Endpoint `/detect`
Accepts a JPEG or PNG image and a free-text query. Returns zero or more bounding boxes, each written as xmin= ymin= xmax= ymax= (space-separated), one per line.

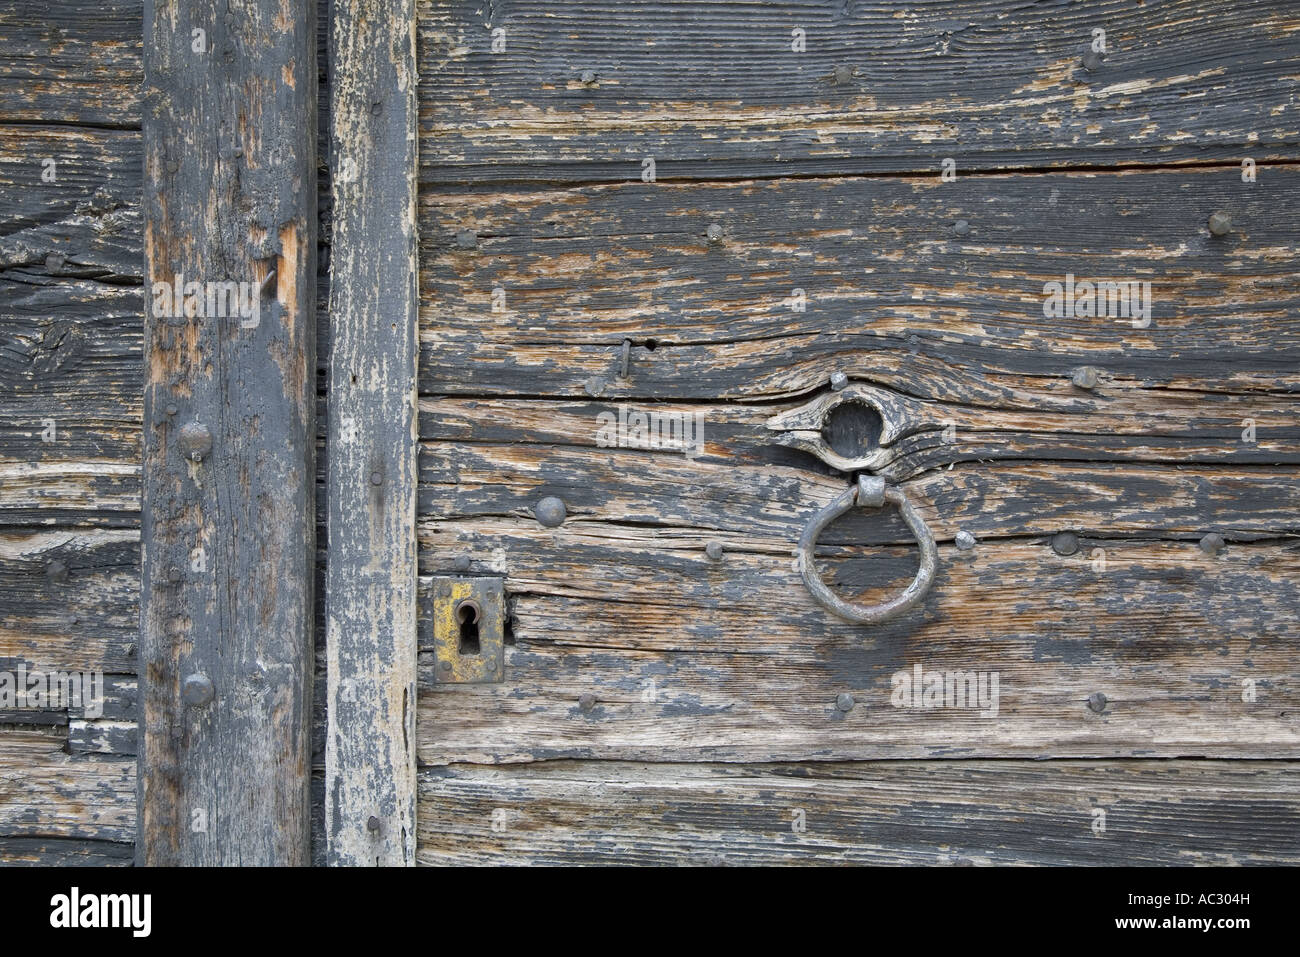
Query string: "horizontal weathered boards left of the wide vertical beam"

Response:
xmin=0 ymin=0 xmax=143 ymax=866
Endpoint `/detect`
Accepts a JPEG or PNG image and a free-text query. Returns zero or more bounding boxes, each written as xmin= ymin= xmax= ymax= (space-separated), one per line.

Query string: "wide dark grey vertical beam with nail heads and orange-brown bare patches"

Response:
xmin=137 ymin=0 xmax=317 ymax=865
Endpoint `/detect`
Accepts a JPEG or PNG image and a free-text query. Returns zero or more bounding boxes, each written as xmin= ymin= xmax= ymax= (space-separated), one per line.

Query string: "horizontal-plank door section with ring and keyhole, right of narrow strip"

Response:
xmin=403 ymin=0 xmax=1300 ymax=863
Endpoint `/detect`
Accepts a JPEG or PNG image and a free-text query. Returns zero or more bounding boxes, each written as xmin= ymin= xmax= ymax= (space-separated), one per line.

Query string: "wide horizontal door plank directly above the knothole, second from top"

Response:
xmin=420 ymin=165 xmax=1300 ymax=397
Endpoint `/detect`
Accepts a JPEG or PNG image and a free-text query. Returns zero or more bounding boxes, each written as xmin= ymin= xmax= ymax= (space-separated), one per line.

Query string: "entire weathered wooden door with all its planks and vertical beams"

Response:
xmin=0 ymin=0 xmax=1300 ymax=863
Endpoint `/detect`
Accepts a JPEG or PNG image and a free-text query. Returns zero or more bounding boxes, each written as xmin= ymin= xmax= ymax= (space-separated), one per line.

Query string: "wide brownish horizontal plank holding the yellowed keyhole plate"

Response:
xmin=420 ymin=522 xmax=1300 ymax=765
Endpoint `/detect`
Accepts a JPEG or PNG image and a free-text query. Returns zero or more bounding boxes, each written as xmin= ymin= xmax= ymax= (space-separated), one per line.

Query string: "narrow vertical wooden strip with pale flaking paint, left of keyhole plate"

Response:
xmin=325 ymin=0 xmax=419 ymax=865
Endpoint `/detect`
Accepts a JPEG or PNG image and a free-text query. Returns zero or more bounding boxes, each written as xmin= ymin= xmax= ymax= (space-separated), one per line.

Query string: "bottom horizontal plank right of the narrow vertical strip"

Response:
xmin=419 ymin=761 xmax=1300 ymax=866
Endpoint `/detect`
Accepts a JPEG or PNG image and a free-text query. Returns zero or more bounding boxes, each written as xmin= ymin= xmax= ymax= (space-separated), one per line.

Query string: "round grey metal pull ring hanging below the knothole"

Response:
xmin=798 ymin=475 xmax=939 ymax=624
